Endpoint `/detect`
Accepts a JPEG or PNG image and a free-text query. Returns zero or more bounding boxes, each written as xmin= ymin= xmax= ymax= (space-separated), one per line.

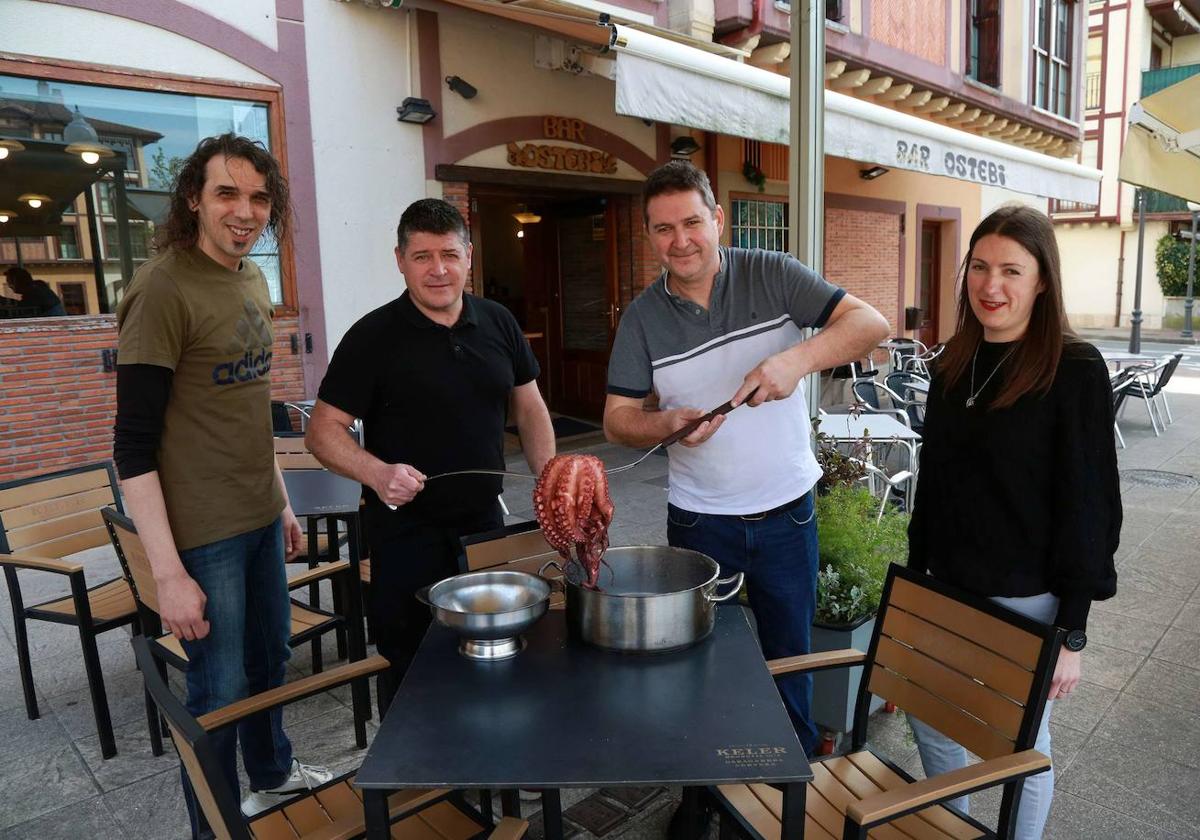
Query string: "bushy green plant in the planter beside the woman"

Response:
xmin=816 ymin=485 xmax=908 ymax=625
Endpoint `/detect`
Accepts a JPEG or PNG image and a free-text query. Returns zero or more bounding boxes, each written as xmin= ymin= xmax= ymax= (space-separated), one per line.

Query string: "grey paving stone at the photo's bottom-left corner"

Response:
xmin=0 ymin=744 xmax=97 ymax=828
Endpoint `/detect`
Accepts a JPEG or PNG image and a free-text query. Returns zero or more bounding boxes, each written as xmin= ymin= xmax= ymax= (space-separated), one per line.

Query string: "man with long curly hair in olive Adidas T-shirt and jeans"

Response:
xmin=114 ymin=134 xmax=332 ymax=838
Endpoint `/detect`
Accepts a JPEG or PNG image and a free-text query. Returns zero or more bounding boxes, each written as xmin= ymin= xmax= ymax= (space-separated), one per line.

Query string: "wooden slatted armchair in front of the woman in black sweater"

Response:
xmin=714 ymin=565 xmax=1063 ymax=840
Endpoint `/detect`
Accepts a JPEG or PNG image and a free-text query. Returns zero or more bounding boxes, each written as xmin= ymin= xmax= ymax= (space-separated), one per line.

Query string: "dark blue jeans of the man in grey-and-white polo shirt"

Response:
xmin=667 ymin=491 xmax=817 ymax=755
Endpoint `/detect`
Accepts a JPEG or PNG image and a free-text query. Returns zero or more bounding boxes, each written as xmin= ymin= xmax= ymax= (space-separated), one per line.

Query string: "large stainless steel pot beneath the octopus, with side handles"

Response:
xmin=541 ymin=546 xmax=742 ymax=653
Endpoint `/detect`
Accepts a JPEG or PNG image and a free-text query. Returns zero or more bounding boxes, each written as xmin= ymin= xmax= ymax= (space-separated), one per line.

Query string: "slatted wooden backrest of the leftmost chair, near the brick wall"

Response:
xmin=0 ymin=461 xmax=121 ymax=558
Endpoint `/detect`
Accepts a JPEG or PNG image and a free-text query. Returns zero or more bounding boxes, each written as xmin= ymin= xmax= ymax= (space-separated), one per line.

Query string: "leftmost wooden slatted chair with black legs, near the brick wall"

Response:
xmin=0 ymin=461 xmax=137 ymax=758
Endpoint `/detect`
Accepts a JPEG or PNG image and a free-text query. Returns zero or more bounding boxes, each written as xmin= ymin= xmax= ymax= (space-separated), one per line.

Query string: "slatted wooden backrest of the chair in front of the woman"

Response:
xmin=854 ymin=565 xmax=1063 ymax=758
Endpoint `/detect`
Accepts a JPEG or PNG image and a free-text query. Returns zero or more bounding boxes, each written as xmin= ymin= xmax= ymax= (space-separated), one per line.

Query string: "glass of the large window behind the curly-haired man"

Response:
xmin=0 ymin=69 xmax=279 ymax=317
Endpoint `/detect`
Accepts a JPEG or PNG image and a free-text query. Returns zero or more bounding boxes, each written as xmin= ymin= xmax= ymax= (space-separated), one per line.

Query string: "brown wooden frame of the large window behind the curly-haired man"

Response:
xmin=0 ymin=55 xmax=300 ymax=317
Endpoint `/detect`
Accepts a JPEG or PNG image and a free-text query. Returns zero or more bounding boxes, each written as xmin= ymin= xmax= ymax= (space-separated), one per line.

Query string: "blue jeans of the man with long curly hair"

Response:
xmin=179 ymin=520 xmax=292 ymax=838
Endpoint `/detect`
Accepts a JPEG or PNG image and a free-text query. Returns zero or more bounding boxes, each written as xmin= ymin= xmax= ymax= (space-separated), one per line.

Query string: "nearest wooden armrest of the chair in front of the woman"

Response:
xmin=846 ymin=750 xmax=1050 ymax=828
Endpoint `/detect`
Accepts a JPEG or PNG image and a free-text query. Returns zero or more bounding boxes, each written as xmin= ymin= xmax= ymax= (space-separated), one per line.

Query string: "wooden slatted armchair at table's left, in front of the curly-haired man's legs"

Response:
xmin=133 ymin=636 xmax=528 ymax=840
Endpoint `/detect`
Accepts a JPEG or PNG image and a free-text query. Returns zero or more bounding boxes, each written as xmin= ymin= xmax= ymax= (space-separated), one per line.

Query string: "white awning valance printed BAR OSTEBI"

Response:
xmin=611 ymin=25 xmax=1102 ymax=204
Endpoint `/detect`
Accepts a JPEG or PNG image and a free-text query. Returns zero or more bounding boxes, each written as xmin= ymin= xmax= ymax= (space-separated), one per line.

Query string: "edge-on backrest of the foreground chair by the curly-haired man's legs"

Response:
xmin=133 ymin=636 xmax=251 ymax=840
